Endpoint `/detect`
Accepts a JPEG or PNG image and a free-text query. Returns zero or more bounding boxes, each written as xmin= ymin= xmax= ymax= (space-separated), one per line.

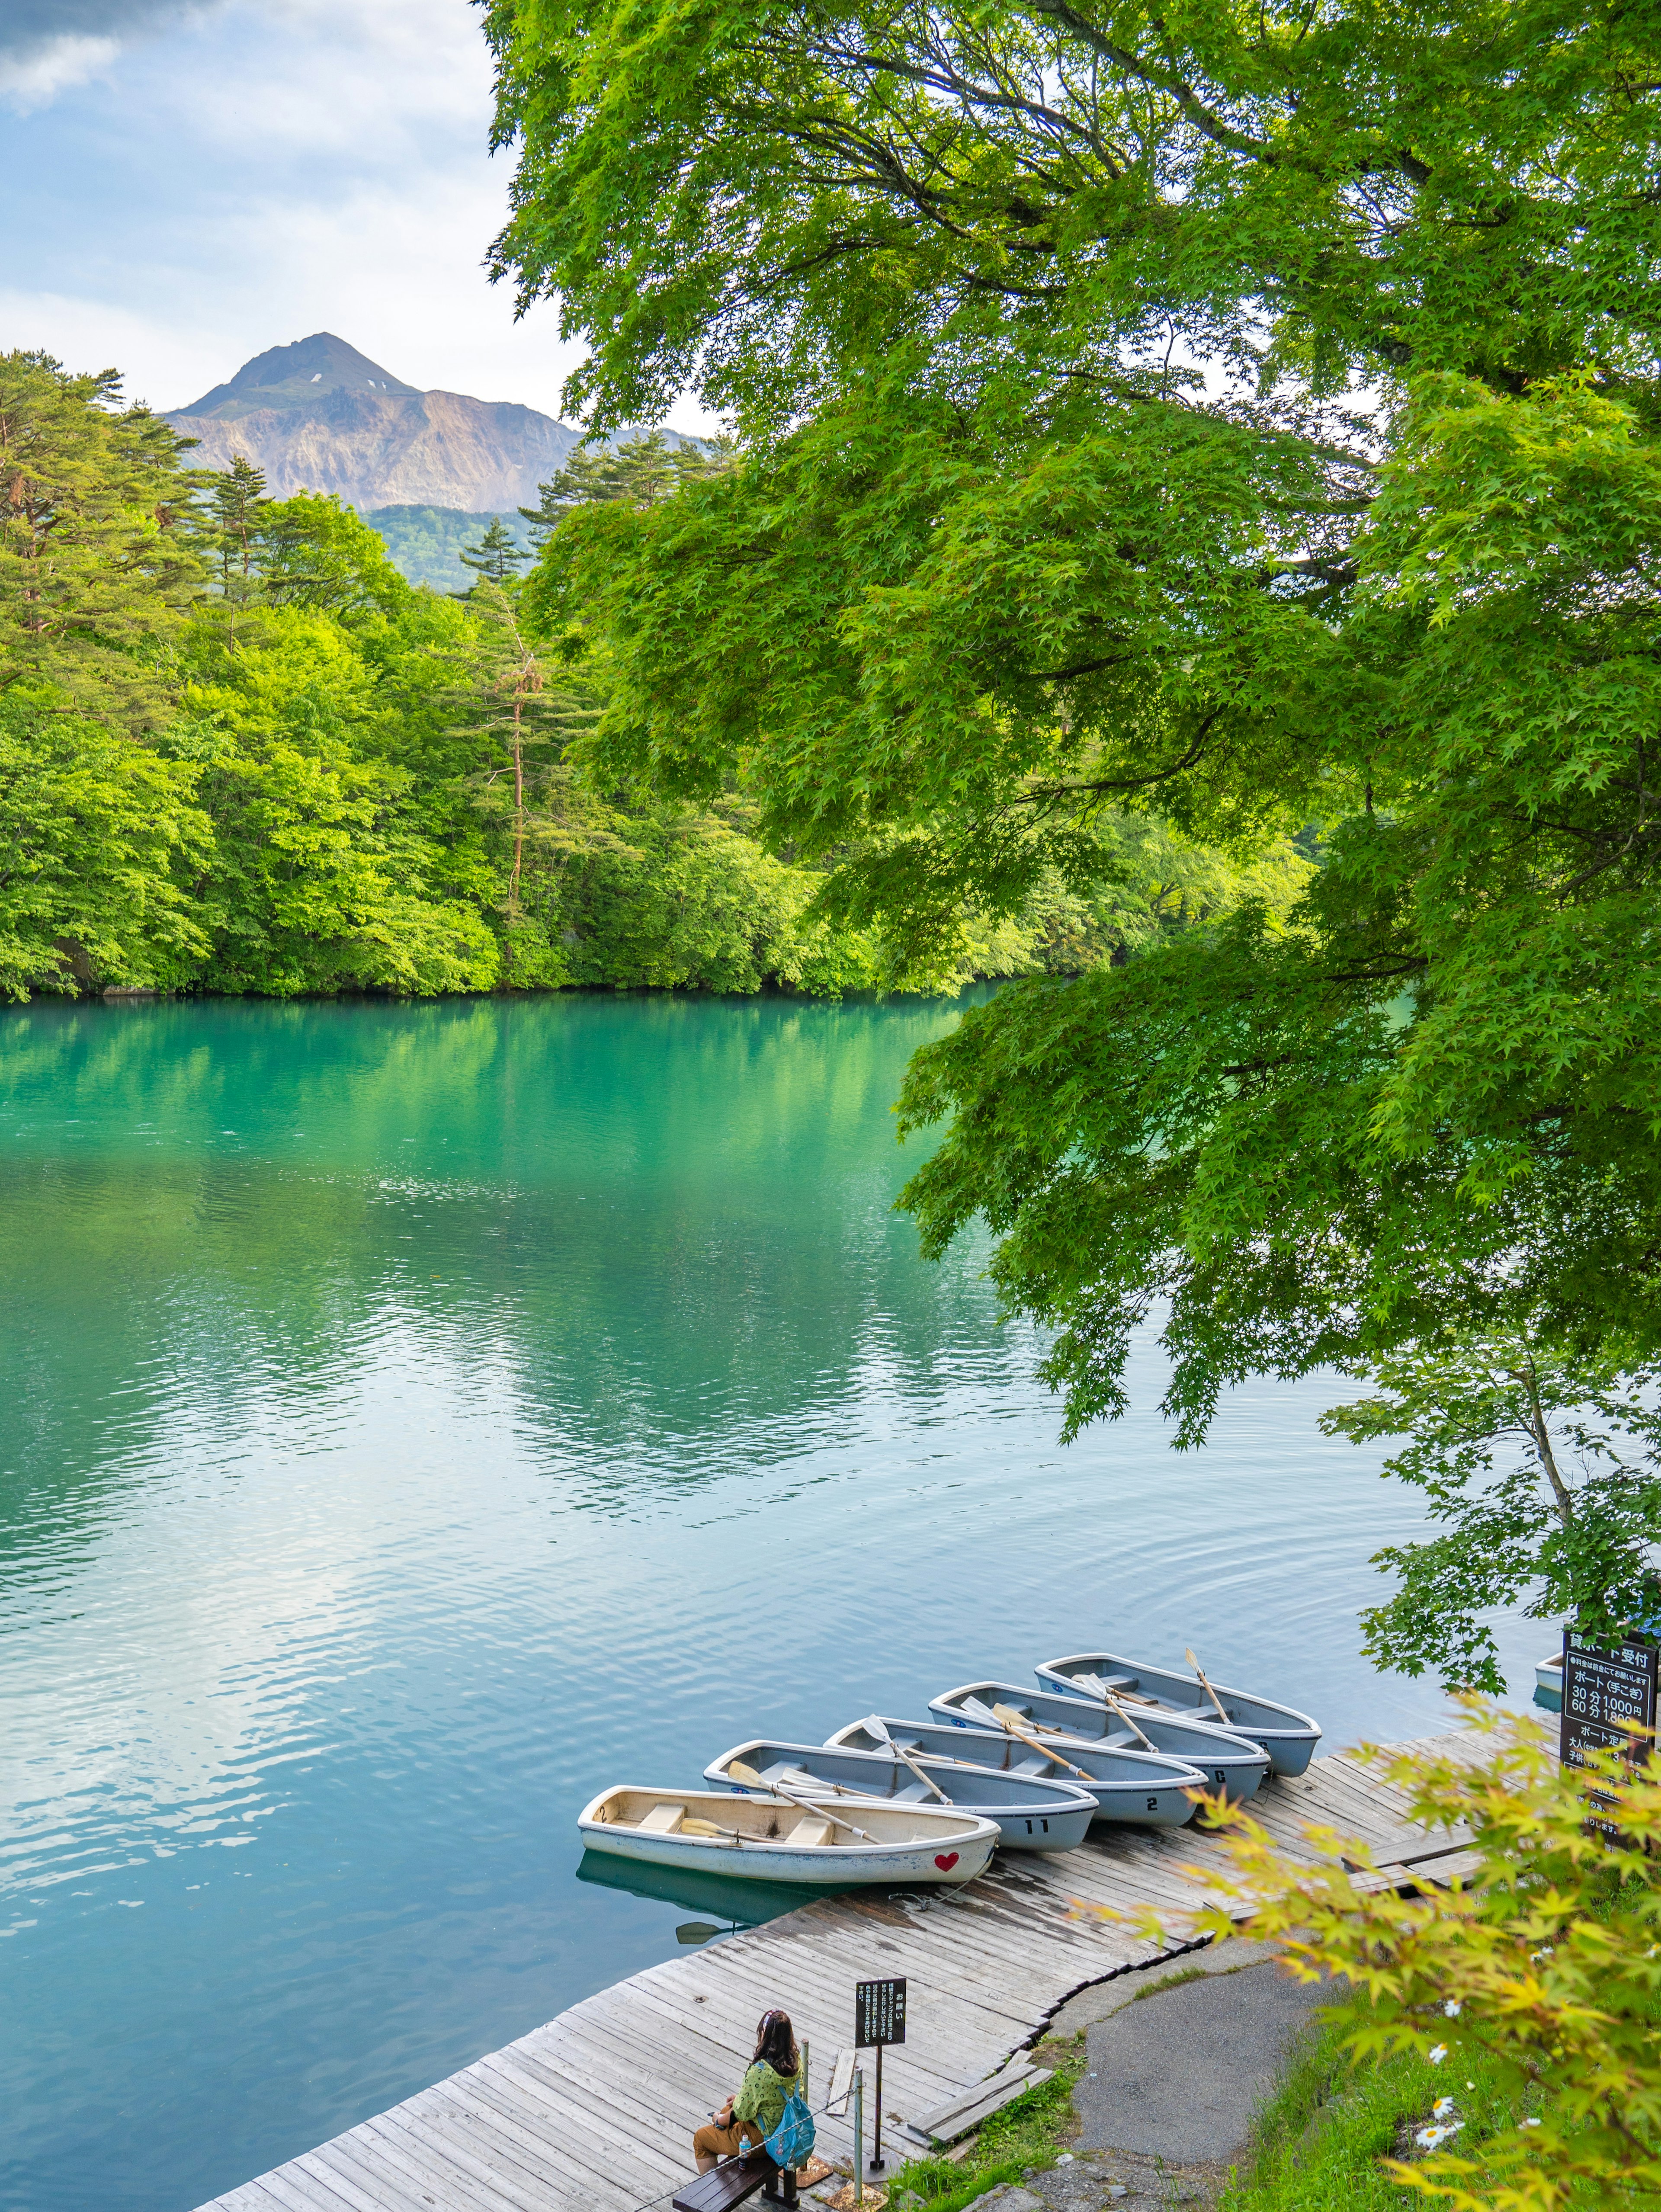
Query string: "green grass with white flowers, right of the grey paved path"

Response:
xmin=1218 ymin=2006 xmax=1520 ymax=2212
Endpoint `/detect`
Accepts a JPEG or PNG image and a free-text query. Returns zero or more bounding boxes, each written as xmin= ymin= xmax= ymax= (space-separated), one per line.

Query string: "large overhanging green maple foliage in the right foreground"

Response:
xmin=489 ymin=0 xmax=1661 ymax=1486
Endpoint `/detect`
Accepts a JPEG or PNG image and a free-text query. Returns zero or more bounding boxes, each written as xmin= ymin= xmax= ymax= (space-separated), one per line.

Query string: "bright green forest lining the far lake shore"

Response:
xmin=0 ymin=365 xmax=1307 ymax=1000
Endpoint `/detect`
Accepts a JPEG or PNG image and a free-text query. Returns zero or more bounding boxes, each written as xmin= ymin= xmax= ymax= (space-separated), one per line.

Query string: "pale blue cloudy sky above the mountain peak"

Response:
xmin=0 ymin=0 xmax=668 ymax=429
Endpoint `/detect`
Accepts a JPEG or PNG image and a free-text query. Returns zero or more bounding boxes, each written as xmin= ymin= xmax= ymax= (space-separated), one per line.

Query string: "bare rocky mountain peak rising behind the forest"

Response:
xmin=168 ymin=332 xmax=582 ymax=516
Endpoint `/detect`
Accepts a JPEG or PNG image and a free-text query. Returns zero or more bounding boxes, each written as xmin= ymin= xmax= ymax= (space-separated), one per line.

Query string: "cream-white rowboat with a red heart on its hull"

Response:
xmin=577 ymin=1783 xmax=997 ymax=1889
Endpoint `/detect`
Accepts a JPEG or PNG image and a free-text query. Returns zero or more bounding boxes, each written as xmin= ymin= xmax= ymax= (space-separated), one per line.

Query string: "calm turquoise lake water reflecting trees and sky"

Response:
xmin=0 ymin=997 xmax=1550 ymax=2212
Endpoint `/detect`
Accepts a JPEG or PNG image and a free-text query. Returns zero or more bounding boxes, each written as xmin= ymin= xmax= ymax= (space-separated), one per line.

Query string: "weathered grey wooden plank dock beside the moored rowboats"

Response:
xmin=201 ymin=1739 xmax=1469 ymax=2212
